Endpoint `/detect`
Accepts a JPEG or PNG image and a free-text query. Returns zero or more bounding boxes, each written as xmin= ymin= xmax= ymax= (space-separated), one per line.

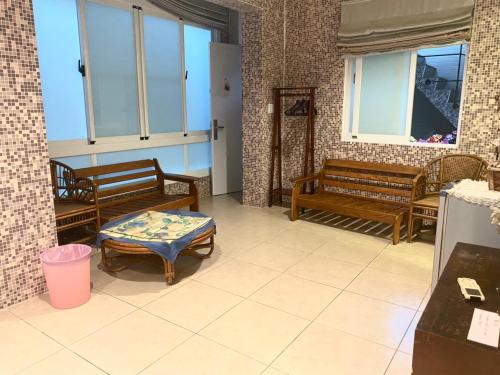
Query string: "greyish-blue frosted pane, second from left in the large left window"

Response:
xmin=86 ymin=2 xmax=139 ymax=137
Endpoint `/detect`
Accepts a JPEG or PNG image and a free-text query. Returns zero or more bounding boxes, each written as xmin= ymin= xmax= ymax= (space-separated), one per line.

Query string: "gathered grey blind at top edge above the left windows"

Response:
xmin=149 ymin=0 xmax=229 ymax=31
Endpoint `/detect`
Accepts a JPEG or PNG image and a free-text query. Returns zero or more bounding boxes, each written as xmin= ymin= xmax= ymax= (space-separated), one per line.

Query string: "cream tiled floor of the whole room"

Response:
xmin=0 ymin=196 xmax=433 ymax=375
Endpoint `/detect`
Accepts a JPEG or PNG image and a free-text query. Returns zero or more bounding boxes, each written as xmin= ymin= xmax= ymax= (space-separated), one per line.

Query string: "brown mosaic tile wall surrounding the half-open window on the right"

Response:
xmin=283 ymin=0 xmax=500 ymax=194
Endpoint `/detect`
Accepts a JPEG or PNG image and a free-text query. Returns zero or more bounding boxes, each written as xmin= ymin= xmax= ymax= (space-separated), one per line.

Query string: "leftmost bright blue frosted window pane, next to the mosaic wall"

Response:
xmin=33 ymin=0 xmax=87 ymax=141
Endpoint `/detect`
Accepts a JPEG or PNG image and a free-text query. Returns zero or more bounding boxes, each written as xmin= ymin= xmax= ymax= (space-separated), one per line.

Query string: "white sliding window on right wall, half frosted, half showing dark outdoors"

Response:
xmin=343 ymin=44 xmax=467 ymax=145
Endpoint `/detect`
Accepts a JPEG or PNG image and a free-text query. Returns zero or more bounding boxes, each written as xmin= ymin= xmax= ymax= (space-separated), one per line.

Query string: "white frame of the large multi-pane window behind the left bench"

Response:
xmin=44 ymin=0 xmax=213 ymax=177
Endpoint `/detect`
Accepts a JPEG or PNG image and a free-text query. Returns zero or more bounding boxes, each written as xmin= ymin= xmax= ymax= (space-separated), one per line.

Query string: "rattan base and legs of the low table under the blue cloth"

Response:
xmin=101 ymin=225 xmax=215 ymax=285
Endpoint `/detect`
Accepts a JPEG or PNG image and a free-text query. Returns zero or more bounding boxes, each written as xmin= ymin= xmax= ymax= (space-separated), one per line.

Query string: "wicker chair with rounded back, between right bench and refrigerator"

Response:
xmin=408 ymin=154 xmax=488 ymax=242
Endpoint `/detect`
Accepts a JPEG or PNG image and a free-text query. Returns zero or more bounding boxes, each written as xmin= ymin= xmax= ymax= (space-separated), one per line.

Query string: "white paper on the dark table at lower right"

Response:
xmin=467 ymin=309 xmax=500 ymax=348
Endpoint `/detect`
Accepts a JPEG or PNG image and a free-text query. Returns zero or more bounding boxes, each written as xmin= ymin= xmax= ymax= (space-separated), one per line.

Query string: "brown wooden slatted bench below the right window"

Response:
xmin=291 ymin=159 xmax=425 ymax=244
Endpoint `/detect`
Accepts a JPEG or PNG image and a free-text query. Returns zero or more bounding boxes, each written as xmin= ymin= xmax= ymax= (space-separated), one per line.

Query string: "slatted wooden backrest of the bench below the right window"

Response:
xmin=319 ymin=159 xmax=423 ymax=203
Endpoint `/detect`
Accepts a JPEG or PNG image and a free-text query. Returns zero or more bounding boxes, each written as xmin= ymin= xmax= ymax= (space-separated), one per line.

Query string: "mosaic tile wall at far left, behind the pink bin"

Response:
xmin=0 ymin=0 xmax=56 ymax=309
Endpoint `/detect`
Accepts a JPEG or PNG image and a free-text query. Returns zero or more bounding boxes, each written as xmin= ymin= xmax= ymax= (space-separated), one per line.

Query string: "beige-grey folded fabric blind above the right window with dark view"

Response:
xmin=337 ymin=0 xmax=474 ymax=55
